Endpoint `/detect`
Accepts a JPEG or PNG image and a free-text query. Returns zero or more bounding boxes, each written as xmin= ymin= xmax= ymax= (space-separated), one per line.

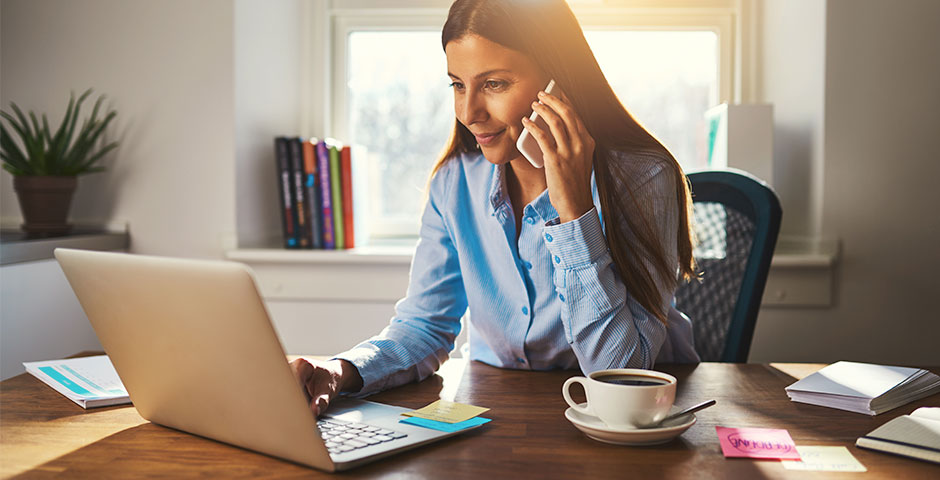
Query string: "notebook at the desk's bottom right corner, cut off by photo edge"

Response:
xmin=855 ymin=407 xmax=940 ymax=463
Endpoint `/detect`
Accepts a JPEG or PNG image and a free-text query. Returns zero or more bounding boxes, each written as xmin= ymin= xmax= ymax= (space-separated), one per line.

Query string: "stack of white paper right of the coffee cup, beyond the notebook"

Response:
xmin=786 ymin=362 xmax=940 ymax=415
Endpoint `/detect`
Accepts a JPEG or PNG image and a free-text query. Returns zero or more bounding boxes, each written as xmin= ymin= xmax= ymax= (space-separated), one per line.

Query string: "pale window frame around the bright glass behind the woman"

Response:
xmin=320 ymin=0 xmax=753 ymax=243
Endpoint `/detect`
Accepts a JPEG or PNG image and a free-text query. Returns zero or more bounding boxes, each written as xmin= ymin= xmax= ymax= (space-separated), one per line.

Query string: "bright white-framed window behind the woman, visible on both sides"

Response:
xmin=327 ymin=2 xmax=733 ymax=239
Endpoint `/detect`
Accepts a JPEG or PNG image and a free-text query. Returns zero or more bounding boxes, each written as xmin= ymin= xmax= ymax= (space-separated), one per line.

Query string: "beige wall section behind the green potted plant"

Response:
xmin=0 ymin=0 xmax=235 ymax=258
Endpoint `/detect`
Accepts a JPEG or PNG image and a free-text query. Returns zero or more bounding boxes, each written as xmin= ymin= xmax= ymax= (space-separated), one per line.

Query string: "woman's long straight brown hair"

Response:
xmin=431 ymin=0 xmax=695 ymax=323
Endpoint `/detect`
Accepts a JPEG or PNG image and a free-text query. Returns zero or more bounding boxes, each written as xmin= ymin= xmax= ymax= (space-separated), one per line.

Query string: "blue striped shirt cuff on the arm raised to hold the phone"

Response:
xmin=542 ymin=207 xmax=608 ymax=269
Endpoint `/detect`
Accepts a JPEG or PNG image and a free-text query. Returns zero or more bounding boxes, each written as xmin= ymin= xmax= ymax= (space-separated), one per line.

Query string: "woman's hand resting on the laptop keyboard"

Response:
xmin=290 ymin=357 xmax=362 ymax=416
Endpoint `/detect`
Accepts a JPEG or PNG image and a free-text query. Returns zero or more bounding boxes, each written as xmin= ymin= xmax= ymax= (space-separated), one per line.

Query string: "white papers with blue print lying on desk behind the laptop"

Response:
xmin=23 ymin=355 xmax=131 ymax=408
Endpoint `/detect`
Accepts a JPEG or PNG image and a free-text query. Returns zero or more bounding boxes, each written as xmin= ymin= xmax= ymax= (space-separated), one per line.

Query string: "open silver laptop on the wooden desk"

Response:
xmin=55 ymin=248 xmax=478 ymax=471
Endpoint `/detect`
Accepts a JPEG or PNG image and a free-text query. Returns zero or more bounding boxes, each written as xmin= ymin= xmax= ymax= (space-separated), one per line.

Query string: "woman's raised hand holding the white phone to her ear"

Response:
xmin=522 ymin=92 xmax=594 ymax=222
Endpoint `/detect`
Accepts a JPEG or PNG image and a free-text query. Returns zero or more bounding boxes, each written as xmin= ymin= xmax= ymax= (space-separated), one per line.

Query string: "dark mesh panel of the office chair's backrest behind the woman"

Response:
xmin=676 ymin=202 xmax=755 ymax=361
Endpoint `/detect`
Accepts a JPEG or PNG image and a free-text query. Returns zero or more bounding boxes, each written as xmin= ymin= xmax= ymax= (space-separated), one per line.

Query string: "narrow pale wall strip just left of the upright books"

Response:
xmin=235 ymin=0 xmax=305 ymax=247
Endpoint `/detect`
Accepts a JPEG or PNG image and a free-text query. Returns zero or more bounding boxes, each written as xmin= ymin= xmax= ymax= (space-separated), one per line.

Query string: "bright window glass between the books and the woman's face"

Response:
xmin=346 ymin=31 xmax=454 ymax=236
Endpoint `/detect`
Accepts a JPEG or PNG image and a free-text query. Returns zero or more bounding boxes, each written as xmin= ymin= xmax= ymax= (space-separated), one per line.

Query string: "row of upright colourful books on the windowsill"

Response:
xmin=274 ymin=136 xmax=356 ymax=250
